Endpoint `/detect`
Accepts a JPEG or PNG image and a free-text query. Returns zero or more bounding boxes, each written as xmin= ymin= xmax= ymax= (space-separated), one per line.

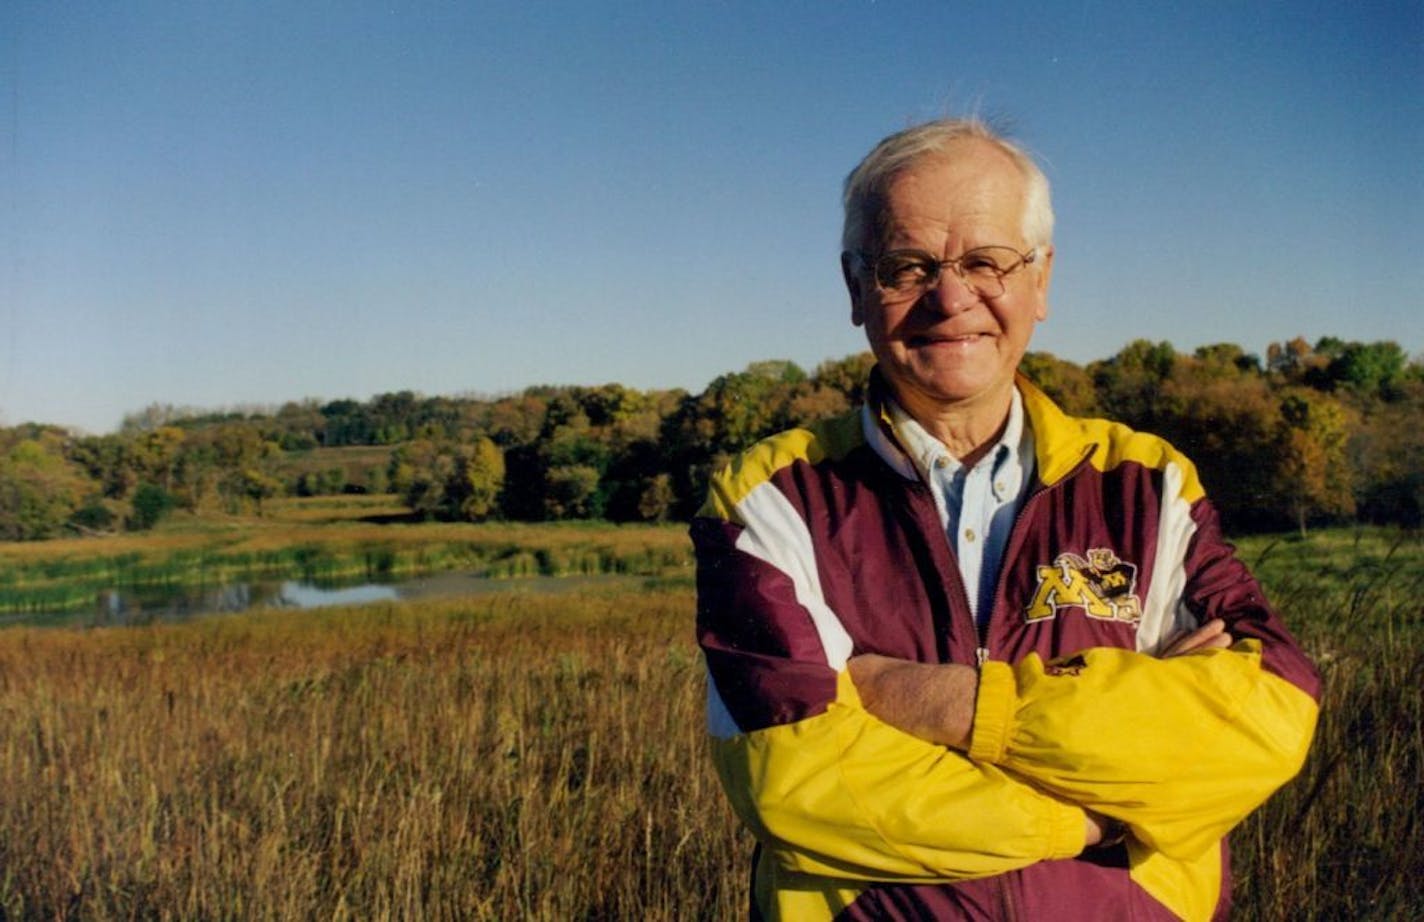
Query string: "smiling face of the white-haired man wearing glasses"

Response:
xmin=843 ymin=141 xmax=1052 ymax=416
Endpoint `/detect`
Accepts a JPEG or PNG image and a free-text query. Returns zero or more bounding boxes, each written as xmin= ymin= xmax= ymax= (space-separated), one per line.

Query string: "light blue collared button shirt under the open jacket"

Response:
xmin=889 ymin=388 xmax=1034 ymax=627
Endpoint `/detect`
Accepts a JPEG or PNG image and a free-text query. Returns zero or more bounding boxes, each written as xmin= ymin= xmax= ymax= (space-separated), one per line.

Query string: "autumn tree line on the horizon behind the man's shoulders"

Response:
xmin=0 ymin=336 xmax=1424 ymax=540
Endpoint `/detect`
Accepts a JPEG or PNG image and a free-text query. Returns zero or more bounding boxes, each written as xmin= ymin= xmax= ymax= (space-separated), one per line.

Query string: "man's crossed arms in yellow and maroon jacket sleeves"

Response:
xmin=693 ymin=520 xmax=1314 ymax=882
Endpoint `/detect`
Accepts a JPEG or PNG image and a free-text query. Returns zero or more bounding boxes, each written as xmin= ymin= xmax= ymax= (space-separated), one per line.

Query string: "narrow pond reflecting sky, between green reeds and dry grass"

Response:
xmin=0 ymin=573 xmax=644 ymax=627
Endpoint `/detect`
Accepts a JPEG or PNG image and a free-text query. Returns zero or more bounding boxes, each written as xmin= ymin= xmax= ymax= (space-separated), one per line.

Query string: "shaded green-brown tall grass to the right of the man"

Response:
xmin=1232 ymin=529 xmax=1424 ymax=919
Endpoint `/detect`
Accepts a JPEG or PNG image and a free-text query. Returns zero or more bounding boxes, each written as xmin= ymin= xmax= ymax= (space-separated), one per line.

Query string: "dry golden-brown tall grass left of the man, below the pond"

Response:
xmin=0 ymin=590 xmax=746 ymax=919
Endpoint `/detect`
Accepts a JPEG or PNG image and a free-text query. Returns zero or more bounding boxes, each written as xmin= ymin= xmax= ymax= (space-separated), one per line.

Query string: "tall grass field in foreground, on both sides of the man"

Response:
xmin=0 ymin=526 xmax=1424 ymax=919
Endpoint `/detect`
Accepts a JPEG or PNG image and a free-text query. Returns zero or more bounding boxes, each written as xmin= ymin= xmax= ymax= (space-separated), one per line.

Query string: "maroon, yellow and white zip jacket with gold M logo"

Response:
xmin=692 ymin=379 xmax=1317 ymax=921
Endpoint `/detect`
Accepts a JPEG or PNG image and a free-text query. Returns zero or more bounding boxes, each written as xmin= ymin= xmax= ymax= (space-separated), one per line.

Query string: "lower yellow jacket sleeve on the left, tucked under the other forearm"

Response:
xmin=712 ymin=671 xmax=1084 ymax=882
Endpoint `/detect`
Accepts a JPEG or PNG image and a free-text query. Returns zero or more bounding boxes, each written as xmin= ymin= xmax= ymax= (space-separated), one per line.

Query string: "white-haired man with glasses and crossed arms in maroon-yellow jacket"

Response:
xmin=692 ymin=121 xmax=1317 ymax=921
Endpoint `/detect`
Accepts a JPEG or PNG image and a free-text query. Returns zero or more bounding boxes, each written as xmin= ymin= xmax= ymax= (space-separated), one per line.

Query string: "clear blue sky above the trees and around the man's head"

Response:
xmin=0 ymin=0 xmax=1424 ymax=432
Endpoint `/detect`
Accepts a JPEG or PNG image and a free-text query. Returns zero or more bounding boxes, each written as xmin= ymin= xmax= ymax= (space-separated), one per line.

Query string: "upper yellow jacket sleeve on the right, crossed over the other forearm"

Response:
xmin=970 ymin=640 xmax=1316 ymax=861
